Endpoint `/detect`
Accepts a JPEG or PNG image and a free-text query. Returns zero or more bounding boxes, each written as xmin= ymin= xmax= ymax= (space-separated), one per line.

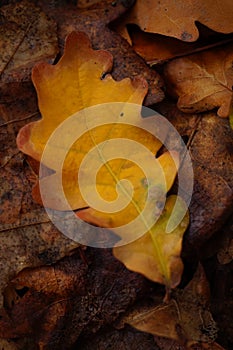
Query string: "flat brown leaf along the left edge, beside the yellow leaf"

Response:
xmin=0 ymin=83 xmax=78 ymax=307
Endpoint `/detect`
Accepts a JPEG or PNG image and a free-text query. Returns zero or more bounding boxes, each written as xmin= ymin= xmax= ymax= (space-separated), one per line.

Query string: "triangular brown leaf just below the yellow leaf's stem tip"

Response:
xmin=123 ymin=266 xmax=217 ymax=346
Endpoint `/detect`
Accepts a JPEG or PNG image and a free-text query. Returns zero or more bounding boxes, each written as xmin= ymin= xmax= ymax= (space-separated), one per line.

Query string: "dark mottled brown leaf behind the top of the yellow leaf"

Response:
xmin=37 ymin=0 xmax=164 ymax=106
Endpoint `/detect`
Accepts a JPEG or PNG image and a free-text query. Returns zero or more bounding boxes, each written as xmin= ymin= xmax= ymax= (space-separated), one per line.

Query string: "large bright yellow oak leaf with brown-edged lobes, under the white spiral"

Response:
xmin=17 ymin=33 xmax=188 ymax=288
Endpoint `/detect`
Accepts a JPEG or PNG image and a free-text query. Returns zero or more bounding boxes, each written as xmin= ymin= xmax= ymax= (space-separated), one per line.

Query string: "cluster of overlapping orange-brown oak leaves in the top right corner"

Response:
xmin=114 ymin=0 xmax=233 ymax=117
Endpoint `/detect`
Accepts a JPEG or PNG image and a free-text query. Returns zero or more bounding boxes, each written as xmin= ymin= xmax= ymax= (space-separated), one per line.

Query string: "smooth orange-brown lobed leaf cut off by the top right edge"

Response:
xmin=116 ymin=0 xmax=233 ymax=41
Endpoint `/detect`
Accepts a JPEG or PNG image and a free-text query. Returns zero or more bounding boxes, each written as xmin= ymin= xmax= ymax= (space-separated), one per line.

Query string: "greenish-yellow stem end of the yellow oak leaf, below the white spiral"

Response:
xmin=113 ymin=196 xmax=189 ymax=289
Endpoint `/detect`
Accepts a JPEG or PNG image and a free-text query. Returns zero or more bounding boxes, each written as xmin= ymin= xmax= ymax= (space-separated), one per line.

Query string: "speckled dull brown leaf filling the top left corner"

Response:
xmin=0 ymin=0 xmax=58 ymax=82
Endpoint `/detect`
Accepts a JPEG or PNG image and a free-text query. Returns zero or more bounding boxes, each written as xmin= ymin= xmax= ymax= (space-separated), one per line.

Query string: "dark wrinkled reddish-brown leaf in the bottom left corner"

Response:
xmin=0 ymin=248 xmax=148 ymax=350
